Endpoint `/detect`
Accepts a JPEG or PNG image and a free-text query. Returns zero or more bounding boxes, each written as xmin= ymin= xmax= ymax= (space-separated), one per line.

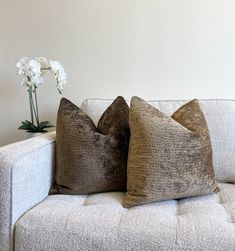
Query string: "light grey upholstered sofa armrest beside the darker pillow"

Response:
xmin=0 ymin=132 xmax=56 ymax=251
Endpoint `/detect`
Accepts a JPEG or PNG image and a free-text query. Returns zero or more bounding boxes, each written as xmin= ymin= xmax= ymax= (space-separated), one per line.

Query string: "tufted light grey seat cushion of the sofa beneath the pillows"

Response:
xmin=15 ymin=183 xmax=235 ymax=251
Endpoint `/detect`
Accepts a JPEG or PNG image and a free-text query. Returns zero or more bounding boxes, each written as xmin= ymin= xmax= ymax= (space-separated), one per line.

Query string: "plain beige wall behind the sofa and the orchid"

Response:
xmin=0 ymin=0 xmax=235 ymax=145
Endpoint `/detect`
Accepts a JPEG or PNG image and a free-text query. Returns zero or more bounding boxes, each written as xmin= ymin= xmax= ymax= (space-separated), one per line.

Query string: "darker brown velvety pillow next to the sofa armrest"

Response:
xmin=51 ymin=97 xmax=130 ymax=194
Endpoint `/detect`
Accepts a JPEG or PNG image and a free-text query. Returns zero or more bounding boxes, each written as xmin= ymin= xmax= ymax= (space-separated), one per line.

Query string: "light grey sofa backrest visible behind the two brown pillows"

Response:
xmin=81 ymin=99 xmax=235 ymax=183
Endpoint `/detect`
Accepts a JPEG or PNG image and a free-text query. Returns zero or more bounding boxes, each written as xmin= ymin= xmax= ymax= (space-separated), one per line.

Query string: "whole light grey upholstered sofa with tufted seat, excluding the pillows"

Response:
xmin=0 ymin=99 xmax=235 ymax=251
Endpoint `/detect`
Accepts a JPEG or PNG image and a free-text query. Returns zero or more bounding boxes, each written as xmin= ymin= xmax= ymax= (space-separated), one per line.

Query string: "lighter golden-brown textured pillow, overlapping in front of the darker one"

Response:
xmin=123 ymin=97 xmax=219 ymax=207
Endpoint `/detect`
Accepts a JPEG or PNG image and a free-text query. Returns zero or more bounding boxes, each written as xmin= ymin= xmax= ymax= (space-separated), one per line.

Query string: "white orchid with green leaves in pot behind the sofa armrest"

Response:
xmin=16 ymin=57 xmax=67 ymax=138
